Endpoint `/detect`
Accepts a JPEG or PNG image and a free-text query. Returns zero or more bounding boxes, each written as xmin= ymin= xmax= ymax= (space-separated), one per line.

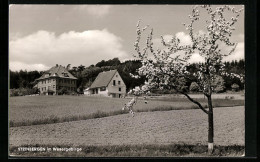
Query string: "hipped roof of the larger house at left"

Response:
xmin=36 ymin=65 xmax=77 ymax=80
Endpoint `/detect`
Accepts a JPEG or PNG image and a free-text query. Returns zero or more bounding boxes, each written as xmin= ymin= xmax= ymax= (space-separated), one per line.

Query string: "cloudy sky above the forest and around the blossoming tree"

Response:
xmin=9 ymin=5 xmax=244 ymax=71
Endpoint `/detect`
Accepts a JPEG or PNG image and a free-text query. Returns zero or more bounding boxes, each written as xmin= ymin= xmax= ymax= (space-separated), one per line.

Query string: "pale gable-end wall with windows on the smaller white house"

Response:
xmin=107 ymin=72 xmax=126 ymax=97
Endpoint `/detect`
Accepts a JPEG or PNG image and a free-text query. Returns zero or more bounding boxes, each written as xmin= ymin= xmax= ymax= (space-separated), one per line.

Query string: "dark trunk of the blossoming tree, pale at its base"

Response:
xmin=208 ymin=95 xmax=214 ymax=154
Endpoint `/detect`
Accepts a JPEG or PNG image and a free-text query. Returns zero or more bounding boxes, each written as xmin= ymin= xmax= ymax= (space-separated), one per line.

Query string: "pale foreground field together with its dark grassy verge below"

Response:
xmin=9 ymin=106 xmax=245 ymax=156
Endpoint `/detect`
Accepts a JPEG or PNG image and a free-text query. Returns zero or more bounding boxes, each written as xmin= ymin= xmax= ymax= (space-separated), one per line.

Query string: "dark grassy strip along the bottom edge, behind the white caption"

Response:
xmin=9 ymin=144 xmax=245 ymax=157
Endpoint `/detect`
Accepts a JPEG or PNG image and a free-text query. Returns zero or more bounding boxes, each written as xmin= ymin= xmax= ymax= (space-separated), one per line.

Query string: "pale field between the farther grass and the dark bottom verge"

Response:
xmin=9 ymin=106 xmax=244 ymax=146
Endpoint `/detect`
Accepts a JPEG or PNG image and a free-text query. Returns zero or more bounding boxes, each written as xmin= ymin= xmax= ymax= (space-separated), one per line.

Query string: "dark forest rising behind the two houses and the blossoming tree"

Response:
xmin=9 ymin=58 xmax=245 ymax=95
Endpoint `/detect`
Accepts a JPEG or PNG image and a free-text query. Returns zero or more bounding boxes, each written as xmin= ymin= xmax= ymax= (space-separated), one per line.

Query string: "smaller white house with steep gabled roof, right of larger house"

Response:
xmin=84 ymin=70 xmax=126 ymax=98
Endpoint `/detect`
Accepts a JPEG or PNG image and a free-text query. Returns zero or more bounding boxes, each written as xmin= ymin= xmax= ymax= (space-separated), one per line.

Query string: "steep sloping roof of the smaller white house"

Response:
xmin=90 ymin=70 xmax=117 ymax=89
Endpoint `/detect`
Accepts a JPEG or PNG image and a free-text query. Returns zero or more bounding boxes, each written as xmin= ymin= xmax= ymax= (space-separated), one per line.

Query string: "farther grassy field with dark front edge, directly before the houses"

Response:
xmin=9 ymin=96 xmax=244 ymax=127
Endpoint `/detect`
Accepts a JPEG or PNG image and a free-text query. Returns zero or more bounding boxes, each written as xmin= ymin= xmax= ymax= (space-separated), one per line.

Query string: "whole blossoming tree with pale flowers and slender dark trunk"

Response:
xmin=127 ymin=5 xmax=244 ymax=153
